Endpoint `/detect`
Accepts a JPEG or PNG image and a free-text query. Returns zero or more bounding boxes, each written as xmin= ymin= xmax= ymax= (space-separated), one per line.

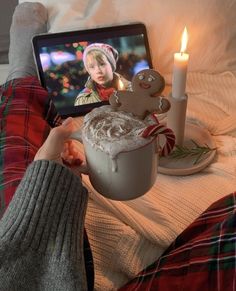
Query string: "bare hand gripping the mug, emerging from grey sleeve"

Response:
xmin=34 ymin=117 xmax=83 ymax=174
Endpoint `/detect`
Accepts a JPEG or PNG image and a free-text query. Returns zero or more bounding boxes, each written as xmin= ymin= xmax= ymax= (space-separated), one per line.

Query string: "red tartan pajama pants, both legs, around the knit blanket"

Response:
xmin=0 ymin=77 xmax=236 ymax=291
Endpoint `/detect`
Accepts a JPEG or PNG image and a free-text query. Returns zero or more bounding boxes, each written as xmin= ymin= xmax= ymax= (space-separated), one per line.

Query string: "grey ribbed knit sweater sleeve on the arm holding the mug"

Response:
xmin=0 ymin=160 xmax=88 ymax=291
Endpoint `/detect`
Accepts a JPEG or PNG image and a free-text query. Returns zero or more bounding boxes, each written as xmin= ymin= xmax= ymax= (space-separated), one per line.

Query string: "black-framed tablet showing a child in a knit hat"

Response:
xmin=33 ymin=23 xmax=152 ymax=117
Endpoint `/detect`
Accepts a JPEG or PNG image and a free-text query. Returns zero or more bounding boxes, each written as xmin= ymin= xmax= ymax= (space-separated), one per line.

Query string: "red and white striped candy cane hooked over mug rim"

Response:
xmin=141 ymin=121 xmax=175 ymax=156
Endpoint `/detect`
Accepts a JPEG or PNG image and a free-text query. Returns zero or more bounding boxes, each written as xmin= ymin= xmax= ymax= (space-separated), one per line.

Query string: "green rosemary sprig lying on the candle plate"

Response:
xmin=170 ymin=140 xmax=216 ymax=165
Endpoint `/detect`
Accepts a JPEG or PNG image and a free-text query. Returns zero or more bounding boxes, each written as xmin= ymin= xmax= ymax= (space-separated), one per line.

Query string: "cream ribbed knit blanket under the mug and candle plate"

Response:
xmin=83 ymin=73 xmax=236 ymax=290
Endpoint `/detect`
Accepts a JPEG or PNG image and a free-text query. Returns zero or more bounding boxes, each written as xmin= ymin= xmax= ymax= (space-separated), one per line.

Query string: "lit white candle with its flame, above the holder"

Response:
xmin=172 ymin=27 xmax=189 ymax=99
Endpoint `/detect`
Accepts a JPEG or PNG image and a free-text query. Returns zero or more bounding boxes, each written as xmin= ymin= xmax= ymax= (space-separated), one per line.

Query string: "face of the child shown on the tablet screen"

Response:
xmin=86 ymin=53 xmax=113 ymax=87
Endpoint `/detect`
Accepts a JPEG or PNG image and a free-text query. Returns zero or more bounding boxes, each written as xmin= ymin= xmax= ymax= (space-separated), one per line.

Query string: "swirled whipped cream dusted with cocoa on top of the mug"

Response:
xmin=82 ymin=105 xmax=154 ymax=158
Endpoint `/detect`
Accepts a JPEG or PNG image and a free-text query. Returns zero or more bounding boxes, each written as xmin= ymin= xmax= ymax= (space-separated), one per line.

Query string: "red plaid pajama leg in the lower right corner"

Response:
xmin=120 ymin=192 xmax=236 ymax=291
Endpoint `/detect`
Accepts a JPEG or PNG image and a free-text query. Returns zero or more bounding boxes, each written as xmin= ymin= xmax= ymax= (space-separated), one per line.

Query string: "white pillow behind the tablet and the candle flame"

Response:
xmin=20 ymin=0 xmax=236 ymax=74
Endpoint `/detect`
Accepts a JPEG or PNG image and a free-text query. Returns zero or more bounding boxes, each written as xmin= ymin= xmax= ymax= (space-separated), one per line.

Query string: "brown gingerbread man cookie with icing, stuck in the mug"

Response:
xmin=109 ymin=69 xmax=170 ymax=119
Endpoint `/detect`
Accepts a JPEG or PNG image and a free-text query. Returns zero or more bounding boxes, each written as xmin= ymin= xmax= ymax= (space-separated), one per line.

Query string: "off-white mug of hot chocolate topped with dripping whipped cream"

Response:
xmin=77 ymin=106 xmax=158 ymax=200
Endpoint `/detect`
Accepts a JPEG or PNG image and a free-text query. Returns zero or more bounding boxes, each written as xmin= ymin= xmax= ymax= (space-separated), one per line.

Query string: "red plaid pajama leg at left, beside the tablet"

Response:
xmin=0 ymin=77 xmax=60 ymax=217
